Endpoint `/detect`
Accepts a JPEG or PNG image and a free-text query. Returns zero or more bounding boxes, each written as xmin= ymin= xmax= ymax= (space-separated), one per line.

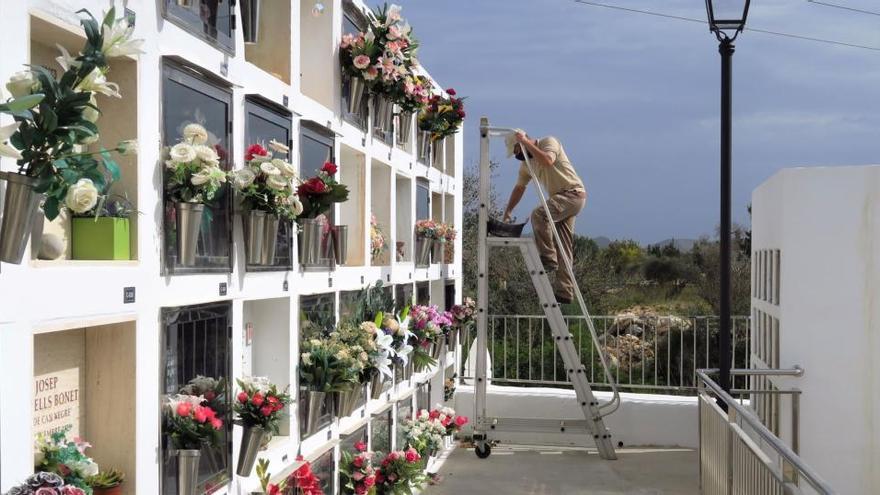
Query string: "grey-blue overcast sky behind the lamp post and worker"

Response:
xmin=398 ymin=0 xmax=880 ymax=242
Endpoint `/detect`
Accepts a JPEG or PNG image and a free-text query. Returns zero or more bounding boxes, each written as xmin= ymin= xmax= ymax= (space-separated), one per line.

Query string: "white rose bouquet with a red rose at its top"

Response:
xmin=229 ymin=140 xmax=303 ymax=220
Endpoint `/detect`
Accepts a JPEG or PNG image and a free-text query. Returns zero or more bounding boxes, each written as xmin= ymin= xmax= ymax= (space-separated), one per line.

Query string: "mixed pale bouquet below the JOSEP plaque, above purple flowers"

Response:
xmin=34 ymin=426 xmax=99 ymax=494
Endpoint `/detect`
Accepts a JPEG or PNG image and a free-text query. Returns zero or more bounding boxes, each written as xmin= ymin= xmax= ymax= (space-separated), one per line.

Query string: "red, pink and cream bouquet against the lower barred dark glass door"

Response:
xmin=163 ymin=394 xmax=223 ymax=450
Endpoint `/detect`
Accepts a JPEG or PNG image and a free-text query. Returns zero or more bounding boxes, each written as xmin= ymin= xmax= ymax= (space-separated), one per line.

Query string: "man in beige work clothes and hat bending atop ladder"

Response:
xmin=504 ymin=129 xmax=587 ymax=304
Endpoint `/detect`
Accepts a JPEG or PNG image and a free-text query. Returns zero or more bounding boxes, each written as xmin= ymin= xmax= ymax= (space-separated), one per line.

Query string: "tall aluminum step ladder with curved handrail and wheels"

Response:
xmin=474 ymin=117 xmax=620 ymax=460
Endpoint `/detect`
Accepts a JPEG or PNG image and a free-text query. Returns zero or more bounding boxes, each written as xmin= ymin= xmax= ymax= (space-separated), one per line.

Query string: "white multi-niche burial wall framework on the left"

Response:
xmin=0 ymin=0 xmax=463 ymax=494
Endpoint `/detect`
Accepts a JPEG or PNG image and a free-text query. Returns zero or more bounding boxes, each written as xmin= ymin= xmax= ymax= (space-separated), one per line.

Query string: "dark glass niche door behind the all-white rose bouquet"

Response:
xmin=162 ymin=62 xmax=233 ymax=274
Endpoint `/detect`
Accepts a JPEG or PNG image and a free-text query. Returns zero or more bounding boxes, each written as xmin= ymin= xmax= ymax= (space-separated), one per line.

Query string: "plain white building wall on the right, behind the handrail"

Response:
xmin=752 ymin=166 xmax=880 ymax=494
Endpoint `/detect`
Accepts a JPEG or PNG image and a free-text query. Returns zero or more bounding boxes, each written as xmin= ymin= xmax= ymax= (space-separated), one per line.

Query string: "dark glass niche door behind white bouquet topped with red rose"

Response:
xmin=241 ymin=95 xmax=294 ymax=271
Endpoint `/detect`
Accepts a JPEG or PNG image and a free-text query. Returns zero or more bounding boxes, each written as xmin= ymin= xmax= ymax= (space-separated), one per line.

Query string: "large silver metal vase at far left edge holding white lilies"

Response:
xmin=0 ymin=172 xmax=43 ymax=265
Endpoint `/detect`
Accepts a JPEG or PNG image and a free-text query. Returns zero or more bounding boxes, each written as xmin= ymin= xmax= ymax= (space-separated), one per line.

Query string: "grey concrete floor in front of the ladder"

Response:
xmin=422 ymin=446 xmax=699 ymax=495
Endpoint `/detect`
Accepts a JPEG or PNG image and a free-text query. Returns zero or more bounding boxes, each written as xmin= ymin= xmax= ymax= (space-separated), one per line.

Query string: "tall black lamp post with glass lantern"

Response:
xmin=706 ymin=0 xmax=750 ymax=393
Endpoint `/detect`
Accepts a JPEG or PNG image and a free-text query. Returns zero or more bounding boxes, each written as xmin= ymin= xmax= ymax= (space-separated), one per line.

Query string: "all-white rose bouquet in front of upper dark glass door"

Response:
xmin=165 ymin=123 xmax=226 ymax=204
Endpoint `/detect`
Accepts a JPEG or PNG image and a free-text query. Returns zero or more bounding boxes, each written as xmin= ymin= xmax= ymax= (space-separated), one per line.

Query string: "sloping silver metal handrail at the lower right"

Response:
xmin=697 ymin=368 xmax=837 ymax=495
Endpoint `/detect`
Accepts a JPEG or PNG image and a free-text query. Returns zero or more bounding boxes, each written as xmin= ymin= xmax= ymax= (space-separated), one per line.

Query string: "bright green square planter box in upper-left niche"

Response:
xmin=70 ymin=217 xmax=131 ymax=260
